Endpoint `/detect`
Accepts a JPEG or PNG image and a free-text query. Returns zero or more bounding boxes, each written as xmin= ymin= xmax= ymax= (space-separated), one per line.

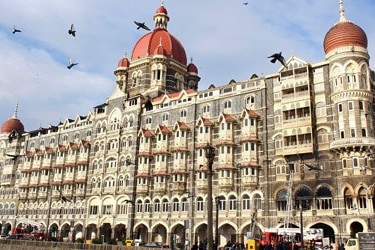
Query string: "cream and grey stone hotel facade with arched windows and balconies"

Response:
xmin=0 ymin=0 xmax=375 ymax=249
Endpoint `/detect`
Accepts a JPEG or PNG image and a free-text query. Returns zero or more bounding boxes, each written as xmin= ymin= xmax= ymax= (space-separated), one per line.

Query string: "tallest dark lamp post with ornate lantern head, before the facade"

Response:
xmin=204 ymin=143 xmax=215 ymax=250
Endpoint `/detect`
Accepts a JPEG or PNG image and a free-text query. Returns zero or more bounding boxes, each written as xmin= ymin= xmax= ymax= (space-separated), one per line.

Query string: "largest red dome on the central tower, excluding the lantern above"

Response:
xmin=131 ymin=28 xmax=187 ymax=65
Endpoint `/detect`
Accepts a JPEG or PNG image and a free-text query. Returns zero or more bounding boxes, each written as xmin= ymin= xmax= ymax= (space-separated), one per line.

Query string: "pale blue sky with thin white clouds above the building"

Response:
xmin=0 ymin=0 xmax=375 ymax=131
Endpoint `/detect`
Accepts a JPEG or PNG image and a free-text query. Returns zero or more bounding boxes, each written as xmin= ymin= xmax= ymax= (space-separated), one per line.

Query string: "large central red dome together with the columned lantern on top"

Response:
xmin=131 ymin=6 xmax=187 ymax=65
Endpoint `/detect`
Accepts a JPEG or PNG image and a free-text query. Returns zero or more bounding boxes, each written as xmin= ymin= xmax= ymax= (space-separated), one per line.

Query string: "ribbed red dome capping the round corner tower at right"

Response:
xmin=323 ymin=21 xmax=367 ymax=54
